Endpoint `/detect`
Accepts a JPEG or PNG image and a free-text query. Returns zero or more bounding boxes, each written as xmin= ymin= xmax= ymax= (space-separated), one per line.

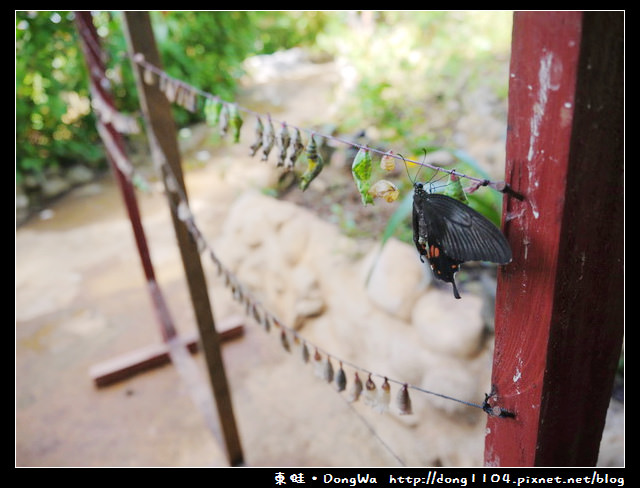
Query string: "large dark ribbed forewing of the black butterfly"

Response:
xmin=414 ymin=192 xmax=511 ymax=264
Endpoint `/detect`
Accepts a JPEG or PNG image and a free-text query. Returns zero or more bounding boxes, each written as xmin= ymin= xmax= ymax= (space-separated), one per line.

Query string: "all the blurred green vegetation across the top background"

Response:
xmin=16 ymin=11 xmax=511 ymax=229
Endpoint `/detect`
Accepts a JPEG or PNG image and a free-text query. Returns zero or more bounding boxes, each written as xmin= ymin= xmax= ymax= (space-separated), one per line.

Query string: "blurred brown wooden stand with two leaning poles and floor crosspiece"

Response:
xmin=76 ymin=12 xmax=243 ymax=466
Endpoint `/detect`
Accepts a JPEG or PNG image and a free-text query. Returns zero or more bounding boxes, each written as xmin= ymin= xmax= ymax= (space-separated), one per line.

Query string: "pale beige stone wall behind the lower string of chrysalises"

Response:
xmin=214 ymin=192 xmax=491 ymax=465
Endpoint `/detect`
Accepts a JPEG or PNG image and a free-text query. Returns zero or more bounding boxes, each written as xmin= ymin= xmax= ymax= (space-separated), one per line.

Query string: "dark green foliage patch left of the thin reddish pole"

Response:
xmin=16 ymin=12 xmax=101 ymax=182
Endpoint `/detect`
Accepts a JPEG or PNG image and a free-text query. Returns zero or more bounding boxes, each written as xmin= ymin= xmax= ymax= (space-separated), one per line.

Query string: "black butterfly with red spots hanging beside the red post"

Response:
xmin=413 ymin=183 xmax=511 ymax=298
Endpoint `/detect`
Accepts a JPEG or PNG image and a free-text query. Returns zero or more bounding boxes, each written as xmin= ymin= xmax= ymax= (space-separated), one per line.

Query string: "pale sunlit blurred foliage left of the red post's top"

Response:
xmin=318 ymin=11 xmax=511 ymax=154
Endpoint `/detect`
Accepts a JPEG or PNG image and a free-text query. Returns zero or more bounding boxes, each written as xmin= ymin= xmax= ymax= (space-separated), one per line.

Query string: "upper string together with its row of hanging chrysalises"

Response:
xmin=131 ymin=53 xmax=522 ymax=203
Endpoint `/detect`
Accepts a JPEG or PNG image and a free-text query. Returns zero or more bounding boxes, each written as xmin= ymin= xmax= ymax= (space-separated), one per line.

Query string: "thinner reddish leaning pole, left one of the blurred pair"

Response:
xmin=75 ymin=12 xmax=176 ymax=341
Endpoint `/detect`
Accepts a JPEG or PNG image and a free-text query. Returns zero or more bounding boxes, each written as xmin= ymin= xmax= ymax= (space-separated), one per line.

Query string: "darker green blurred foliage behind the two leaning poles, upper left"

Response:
xmin=16 ymin=11 xmax=326 ymax=181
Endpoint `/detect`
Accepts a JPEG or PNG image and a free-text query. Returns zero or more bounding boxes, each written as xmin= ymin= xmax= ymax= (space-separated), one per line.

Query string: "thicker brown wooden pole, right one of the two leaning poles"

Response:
xmin=123 ymin=11 xmax=243 ymax=466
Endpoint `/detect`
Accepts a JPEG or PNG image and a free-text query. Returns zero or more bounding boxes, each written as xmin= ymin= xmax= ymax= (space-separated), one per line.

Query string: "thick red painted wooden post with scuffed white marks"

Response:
xmin=485 ymin=12 xmax=624 ymax=466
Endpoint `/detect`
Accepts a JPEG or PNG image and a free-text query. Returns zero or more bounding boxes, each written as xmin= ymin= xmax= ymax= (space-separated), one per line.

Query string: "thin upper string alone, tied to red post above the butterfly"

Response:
xmin=132 ymin=53 xmax=520 ymax=197
